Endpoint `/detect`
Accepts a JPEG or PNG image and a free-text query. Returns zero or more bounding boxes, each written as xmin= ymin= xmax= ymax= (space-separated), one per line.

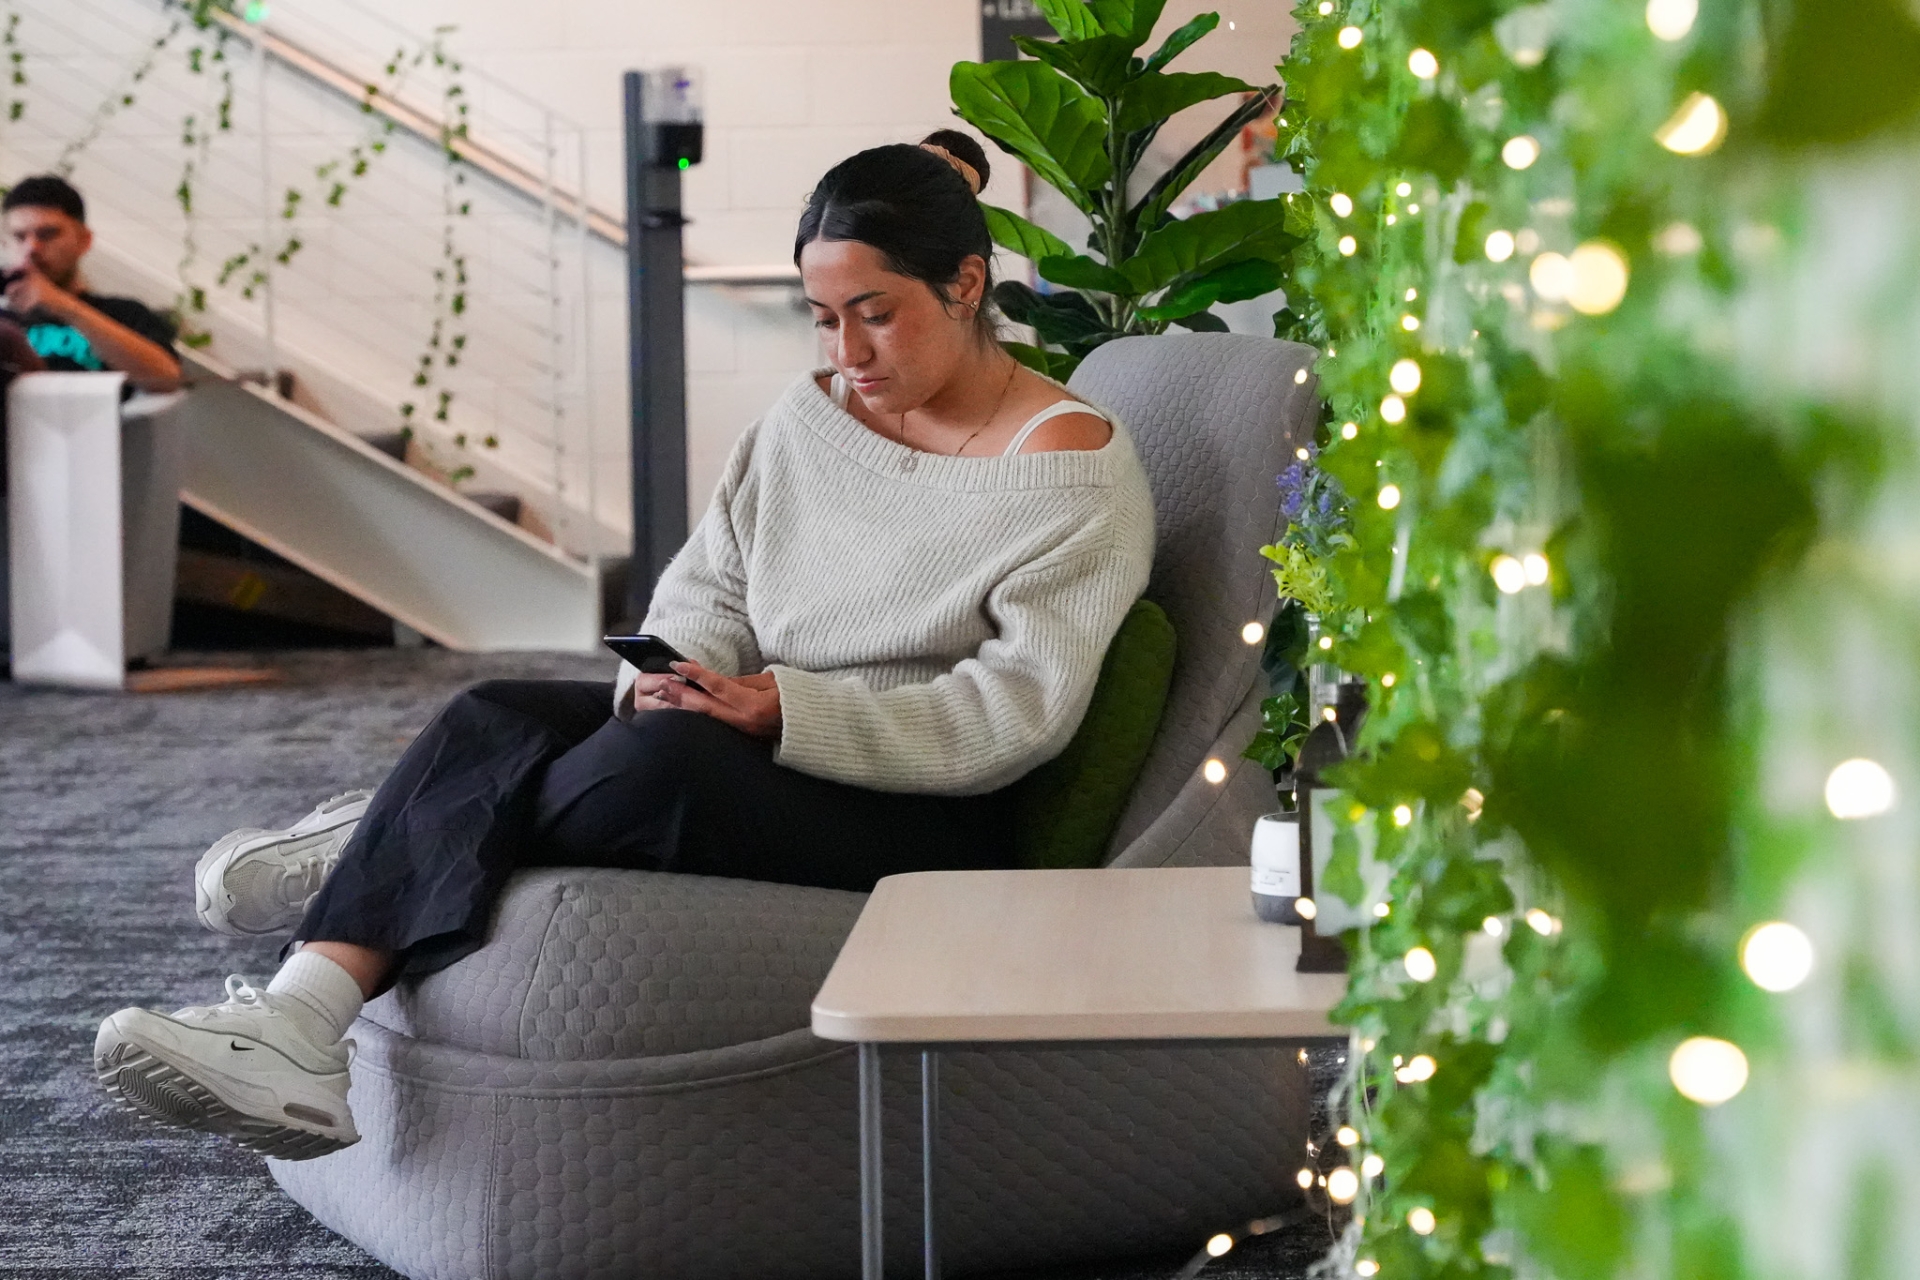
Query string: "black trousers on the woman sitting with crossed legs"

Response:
xmin=294 ymin=679 xmax=1014 ymax=979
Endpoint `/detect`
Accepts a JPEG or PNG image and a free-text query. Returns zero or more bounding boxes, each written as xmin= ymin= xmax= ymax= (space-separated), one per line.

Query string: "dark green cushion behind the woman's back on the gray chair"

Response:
xmin=1018 ymin=601 xmax=1173 ymax=867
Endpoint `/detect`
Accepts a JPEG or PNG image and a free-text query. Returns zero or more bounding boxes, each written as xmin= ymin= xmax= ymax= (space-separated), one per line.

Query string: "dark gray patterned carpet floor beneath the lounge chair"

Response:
xmin=0 ymin=651 xmax=1334 ymax=1280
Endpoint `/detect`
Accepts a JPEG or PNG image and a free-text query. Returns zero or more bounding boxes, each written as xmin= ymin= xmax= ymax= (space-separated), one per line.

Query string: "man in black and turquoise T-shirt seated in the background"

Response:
xmin=0 ymin=175 xmax=180 ymax=391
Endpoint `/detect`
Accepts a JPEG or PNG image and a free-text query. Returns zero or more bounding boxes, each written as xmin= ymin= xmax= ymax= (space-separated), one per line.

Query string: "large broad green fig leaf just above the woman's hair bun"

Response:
xmin=948 ymin=61 xmax=1114 ymax=213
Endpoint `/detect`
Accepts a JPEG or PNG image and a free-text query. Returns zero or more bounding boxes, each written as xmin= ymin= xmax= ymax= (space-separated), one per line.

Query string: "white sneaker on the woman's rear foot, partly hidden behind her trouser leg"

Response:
xmin=194 ymin=791 xmax=372 ymax=936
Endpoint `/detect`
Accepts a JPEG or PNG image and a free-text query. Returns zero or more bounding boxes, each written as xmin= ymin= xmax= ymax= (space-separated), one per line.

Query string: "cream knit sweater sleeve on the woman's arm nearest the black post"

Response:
xmin=612 ymin=424 xmax=766 ymax=718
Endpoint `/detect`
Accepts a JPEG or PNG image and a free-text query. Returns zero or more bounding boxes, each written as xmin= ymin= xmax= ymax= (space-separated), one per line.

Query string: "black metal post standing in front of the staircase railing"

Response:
xmin=624 ymin=71 xmax=687 ymax=626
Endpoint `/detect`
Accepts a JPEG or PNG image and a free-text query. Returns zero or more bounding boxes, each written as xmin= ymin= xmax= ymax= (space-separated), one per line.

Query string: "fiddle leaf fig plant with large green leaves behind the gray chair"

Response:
xmin=950 ymin=0 xmax=1311 ymax=378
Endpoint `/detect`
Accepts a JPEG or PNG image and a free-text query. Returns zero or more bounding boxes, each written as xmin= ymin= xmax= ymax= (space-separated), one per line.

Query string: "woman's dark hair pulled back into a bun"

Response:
xmin=793 ymin=129 xmax=993 ymax=336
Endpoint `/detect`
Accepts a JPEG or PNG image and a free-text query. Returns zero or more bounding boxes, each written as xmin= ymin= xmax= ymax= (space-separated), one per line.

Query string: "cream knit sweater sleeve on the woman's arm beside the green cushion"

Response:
xmin=772 ymin=547 xmax=1148 ymax=796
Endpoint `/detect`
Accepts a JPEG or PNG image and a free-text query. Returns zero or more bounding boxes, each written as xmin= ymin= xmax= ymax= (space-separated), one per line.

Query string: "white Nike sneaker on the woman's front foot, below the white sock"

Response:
xmin=94 ymin=975 xmax=359 ymax=1159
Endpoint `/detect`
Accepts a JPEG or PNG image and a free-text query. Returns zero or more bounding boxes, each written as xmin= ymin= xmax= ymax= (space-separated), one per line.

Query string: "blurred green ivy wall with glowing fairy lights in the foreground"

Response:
xmin=1281 ymin=0 xmax=1920 ymax=1280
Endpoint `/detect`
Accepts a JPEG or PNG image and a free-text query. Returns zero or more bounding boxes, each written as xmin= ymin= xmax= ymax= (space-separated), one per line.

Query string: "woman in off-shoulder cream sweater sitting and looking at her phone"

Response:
xmin=94 ymin=130 xmax=1154 ymax=1159
